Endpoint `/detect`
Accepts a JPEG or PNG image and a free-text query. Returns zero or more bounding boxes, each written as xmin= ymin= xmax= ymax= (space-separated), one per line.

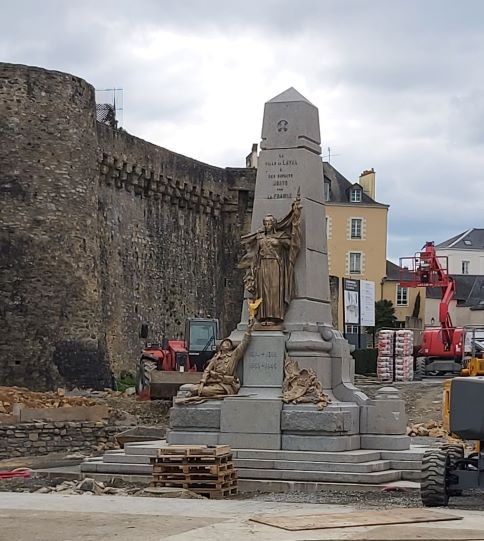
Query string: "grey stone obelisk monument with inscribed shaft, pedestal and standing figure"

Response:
xmin=168 ymin=88 xmax=409 ymax=451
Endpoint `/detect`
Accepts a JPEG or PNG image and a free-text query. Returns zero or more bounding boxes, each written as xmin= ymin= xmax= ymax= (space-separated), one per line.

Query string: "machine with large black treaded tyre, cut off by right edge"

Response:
xmin=420 ymin=327 xmax=484 ymax=507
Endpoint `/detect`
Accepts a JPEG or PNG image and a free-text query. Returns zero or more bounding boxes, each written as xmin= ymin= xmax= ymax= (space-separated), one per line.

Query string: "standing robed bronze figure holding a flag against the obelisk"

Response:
xmin=239 ymin=195 xmax=301 ymax=326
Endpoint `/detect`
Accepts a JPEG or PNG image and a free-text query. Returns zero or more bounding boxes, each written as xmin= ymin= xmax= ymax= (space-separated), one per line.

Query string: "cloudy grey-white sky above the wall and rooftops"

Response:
xmin=0 ymin=0 xmax=484 ymax=260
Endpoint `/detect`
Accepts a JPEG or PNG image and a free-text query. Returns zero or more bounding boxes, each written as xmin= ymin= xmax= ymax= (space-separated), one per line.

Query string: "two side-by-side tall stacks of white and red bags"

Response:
xmin=376 ymin=329 xmax=413 ymax=382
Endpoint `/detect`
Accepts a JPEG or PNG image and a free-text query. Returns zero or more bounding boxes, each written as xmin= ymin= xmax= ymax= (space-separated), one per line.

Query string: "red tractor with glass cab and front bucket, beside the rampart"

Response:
xmin=136 ymin=318 xmax=219 ymax=400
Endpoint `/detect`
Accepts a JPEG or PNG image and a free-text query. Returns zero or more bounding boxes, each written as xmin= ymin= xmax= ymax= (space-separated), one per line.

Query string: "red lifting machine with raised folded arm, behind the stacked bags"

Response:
xmin=400 ymin=242 xmax=463 ymax=379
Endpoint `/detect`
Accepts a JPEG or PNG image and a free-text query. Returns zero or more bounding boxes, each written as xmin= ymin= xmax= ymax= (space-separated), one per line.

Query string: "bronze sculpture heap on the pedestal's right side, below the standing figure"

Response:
xmin=282 ymin=354 xmax=330 ymax=409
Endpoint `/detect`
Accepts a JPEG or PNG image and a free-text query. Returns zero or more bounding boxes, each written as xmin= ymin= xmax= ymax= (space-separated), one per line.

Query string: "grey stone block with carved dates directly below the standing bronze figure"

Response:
xmin=242 ymin=331 xmax=286 ymax=388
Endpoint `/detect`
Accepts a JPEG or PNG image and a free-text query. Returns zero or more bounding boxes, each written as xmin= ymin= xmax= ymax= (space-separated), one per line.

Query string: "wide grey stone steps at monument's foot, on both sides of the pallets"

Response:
xmin=81 ymin=440 xmax=426 ymax=492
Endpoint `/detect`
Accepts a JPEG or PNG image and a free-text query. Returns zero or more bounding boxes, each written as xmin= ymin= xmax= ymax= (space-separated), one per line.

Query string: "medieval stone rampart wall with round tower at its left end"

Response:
xmin=0 ymin=64 xmax=255 ymax=388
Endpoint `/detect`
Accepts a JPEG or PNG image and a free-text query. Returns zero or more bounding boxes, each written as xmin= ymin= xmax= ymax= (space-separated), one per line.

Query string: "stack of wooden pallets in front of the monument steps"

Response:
xmin=151 ymin=445 xmax=237 ymax=498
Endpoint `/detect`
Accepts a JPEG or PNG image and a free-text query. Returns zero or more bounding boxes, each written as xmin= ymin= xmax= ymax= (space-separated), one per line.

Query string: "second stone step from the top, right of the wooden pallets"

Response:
xmin=234 ymin=458 xmax=391 ymax=473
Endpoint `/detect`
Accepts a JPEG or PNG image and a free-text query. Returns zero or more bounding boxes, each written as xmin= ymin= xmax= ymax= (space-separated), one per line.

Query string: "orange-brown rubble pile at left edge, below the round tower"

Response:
xmin=0 ymin=387 xmax=99 ymax=414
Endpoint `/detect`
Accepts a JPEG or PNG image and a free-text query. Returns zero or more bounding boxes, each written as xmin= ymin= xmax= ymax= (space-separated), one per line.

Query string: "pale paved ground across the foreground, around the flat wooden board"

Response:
xmin=0 ymin=492 xmax=484 ymax=541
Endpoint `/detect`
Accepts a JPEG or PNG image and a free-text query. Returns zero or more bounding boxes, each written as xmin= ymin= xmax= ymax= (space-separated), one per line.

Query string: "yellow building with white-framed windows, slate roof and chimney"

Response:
xmin=323 ymin=162 xmax=389 ymax=333
